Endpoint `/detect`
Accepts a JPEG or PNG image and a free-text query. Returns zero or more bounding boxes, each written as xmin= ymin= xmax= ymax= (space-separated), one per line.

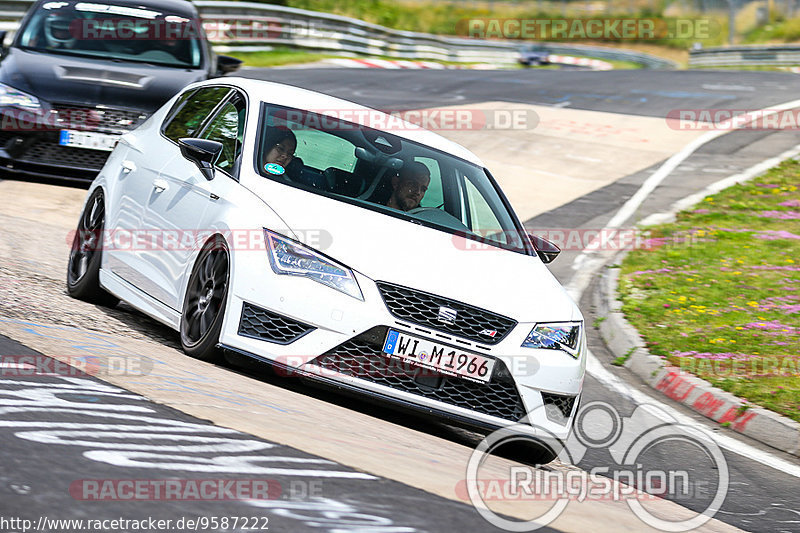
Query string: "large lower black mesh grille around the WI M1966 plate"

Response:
xmin=312 ymin=326 xmax=526 ymax=422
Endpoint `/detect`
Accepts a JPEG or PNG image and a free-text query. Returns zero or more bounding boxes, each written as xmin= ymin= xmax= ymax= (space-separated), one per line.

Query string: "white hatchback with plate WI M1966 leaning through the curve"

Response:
xmin=67 ymin=78 xmax=586 ymax=460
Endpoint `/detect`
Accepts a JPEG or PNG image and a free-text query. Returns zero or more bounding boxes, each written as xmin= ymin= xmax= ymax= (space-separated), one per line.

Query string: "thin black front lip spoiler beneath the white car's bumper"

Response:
xmin=219 ymin=344 xmax=513 ymax=432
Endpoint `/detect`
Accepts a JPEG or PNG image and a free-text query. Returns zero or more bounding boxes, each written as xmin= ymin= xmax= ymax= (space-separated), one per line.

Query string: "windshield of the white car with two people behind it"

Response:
xmin=256 ymin=105 xmax=529 ymax=253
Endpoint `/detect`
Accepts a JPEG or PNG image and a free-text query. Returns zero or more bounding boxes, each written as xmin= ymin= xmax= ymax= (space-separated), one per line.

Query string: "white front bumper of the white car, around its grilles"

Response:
xmin=221 ymin=264 xmax=585 ymax=440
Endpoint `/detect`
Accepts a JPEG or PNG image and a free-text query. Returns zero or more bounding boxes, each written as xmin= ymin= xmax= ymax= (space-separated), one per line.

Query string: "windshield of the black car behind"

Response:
xmin=18 ymin=2 xmax=202 ymax=68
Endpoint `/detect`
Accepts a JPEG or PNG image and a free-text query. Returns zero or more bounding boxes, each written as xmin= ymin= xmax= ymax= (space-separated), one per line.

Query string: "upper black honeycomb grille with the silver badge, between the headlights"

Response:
xmin=377 ymin=281 xmax=517 ymax=344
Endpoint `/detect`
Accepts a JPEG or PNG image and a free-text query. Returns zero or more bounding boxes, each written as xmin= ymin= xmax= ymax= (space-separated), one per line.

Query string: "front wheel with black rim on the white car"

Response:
xmin=180 ymin=236 xmax=230 ymax=362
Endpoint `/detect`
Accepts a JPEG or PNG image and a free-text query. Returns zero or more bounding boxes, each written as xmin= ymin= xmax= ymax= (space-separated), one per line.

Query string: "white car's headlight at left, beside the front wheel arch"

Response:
xmin=264 ymin=229 xmax=364 ymax=301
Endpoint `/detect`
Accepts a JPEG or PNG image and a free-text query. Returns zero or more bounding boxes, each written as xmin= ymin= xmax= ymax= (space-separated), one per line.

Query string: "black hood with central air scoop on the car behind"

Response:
xmin=0 ymin=47 xmax=206 ymax=112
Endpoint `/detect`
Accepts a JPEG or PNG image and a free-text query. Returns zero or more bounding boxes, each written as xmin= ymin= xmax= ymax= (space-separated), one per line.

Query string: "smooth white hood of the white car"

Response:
xmin=253 ymin=180 xmax=581 ymax=322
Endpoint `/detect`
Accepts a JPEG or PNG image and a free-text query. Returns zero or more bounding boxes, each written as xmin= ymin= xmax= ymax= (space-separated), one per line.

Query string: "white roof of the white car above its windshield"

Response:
xmin=212 ymin=76 xmax=485 ymax=167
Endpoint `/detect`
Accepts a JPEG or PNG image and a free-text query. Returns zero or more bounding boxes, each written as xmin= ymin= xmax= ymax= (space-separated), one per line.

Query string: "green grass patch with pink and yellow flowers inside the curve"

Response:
xmin=619 ymin=161 xmax=800 ymax=421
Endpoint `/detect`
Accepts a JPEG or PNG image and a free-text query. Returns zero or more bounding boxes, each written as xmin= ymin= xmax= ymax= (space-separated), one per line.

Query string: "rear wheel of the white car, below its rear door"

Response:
xmin=67 ymin=188 xmax=119 ymax=307
